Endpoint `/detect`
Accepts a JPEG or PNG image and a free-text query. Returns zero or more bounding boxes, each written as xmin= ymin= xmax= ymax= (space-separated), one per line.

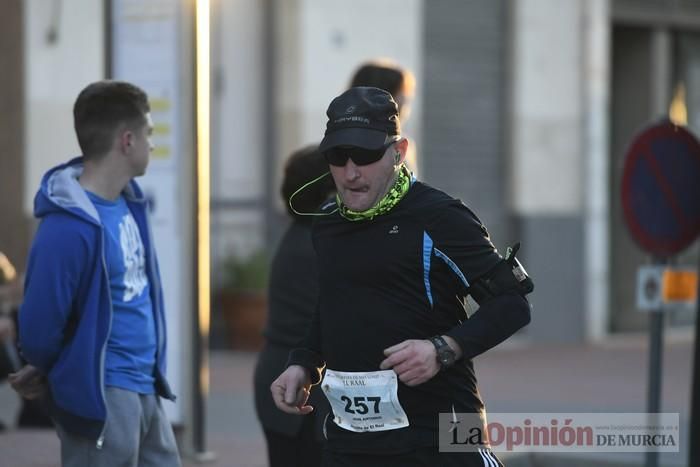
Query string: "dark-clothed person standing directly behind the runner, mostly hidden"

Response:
xmin=255 ymin=146 xmax=335 ymax=467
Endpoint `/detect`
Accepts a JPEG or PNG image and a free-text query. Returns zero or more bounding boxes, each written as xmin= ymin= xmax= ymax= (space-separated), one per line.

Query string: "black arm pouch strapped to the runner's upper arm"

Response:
xmin=469 ymin=243 xmax=535 ymax=304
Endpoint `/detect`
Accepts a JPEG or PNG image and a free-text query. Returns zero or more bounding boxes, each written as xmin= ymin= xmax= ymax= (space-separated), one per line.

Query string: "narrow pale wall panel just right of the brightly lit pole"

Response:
xmin=211 ymin=0 xmax=272 ymax=270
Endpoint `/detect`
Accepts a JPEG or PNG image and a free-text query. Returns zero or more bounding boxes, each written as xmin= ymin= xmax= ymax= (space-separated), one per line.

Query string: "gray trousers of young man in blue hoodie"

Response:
xmin=57 ymin=387 xmax=181 ymax=467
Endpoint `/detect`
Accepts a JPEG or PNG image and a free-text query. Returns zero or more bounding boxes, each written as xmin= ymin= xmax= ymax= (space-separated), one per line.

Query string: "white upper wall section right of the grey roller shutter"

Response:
xmin=511 ymin=0 xmax=583 ymax=215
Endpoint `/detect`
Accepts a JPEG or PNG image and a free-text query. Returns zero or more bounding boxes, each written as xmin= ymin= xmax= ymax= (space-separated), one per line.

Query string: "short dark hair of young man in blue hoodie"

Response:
xmin=73 ymin=80 xmax=151 ymax=158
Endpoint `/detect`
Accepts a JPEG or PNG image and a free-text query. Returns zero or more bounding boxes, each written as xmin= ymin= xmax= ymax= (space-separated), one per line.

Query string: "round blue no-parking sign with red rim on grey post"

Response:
xmin=622 ymin=121 xmax=700 ymax=467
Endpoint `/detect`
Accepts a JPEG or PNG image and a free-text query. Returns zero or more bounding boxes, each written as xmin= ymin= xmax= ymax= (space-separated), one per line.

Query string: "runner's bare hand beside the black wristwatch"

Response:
xmin=379 ymin=336 xmax=462 ymax=386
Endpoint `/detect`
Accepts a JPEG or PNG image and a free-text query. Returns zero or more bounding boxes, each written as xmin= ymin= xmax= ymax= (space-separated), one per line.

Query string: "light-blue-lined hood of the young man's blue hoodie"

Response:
xmin=34 ymin=157 xmax=146 ymax=224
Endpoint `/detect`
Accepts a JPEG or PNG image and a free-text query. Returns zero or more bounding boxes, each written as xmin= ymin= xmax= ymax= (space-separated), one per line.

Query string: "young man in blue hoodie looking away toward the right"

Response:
xmin=10 ymin=81 xmax=181 ymax=467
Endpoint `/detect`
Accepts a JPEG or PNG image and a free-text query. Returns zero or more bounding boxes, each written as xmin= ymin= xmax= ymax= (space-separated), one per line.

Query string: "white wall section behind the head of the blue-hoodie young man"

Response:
xmin=24 ymin=0 xmax=104 ymax=215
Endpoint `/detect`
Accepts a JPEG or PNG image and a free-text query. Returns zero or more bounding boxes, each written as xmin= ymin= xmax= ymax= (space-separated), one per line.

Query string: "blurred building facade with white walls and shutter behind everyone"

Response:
xmin=0 ymin=0 xmax=700 ymax=341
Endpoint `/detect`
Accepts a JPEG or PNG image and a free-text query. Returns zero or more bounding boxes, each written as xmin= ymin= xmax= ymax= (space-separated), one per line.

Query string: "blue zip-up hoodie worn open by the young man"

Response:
xmin=19 ymin=157 xmax=175 ymax=443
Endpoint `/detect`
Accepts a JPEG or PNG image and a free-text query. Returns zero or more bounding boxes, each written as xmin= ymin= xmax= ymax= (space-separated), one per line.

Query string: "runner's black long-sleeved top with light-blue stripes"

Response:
xmin=290 ymin=182 xmax=530 ymax=453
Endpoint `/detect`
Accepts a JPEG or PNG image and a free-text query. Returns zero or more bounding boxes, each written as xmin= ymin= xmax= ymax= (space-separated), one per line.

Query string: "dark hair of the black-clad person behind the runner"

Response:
xmin=280 ymin=145 xmax=335 ymax=222
